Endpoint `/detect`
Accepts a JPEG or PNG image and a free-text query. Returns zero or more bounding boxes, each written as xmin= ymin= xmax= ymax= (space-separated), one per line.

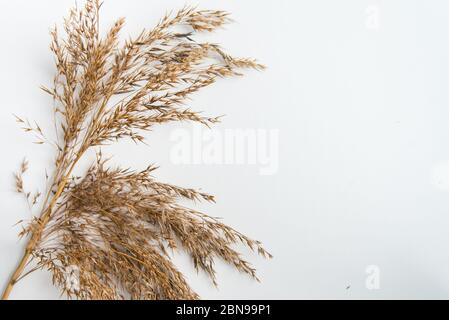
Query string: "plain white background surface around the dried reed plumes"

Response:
xmin=0 ymin=0 xmax=449 ymax=299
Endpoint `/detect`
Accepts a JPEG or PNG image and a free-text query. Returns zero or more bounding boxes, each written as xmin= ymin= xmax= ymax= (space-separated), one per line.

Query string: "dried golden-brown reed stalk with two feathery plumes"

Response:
xmin=3 ymin=0 xmax=271 ymax=299
